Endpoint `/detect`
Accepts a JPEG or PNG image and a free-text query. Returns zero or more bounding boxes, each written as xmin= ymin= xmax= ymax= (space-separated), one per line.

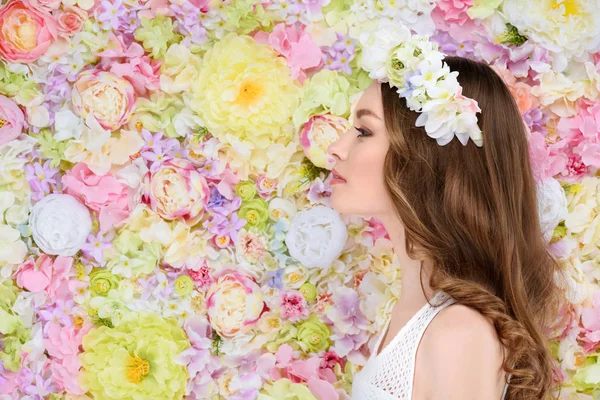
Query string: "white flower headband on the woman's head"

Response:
xmin=360 ymin=20 xmax=483 ymax=147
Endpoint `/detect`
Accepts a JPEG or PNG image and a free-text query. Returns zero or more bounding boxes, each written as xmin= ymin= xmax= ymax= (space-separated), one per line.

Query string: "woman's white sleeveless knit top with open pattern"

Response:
xmin=352 ymin=292 xmax=508 ymax=400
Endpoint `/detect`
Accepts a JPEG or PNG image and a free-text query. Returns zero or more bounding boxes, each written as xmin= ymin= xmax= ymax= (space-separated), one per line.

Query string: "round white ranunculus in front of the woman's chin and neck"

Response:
xmin=285 ymin=206 xmax=348 ymax=268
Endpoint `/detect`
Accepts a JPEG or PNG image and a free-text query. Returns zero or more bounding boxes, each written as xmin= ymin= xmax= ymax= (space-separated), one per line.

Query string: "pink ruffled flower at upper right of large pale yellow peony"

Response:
xmin=254 ymin=24 xmax=321 ymax=83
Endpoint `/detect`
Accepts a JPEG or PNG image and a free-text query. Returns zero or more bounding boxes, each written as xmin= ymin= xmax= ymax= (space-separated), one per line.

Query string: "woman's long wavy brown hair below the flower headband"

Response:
xmin=381 ymin=57 xmax=562 ymax=400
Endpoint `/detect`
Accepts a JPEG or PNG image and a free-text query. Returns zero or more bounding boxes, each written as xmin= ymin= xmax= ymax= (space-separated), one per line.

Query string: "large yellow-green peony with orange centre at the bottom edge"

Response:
xmin=79 ymin=312 xmax=190 ymax=400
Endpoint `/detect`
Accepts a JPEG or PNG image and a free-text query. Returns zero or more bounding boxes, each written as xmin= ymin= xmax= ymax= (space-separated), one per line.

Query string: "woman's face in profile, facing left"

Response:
xmin=328 ymin=82 xmax=392 ymax=217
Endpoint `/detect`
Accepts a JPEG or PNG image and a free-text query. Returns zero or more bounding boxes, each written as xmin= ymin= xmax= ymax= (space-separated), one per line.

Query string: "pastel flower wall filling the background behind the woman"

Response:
xmin=0 ymin=0 xmax=600 ymax=400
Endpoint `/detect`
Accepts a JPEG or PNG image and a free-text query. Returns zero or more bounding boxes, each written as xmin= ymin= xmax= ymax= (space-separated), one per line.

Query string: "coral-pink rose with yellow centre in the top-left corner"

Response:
xmin=0 ymin=0 xmax=57 ymax=63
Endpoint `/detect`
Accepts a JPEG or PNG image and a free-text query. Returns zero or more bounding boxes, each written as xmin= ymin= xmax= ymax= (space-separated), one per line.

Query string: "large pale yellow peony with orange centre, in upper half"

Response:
xmin=192 ymin=33 xmax=302 ymax=169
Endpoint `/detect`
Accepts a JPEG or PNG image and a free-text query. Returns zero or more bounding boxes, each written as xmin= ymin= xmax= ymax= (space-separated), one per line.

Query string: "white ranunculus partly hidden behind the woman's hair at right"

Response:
xmin=537 ymin=178 xmax=568 ymax=241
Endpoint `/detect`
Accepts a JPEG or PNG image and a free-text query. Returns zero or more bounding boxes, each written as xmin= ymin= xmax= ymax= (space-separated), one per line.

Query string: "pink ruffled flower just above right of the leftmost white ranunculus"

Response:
xmin=62 ymin=163 xmax=130 ymax=232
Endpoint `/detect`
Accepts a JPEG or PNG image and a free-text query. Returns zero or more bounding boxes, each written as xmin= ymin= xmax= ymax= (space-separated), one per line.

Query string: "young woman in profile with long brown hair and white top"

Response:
xmin=328 ymin=48 xmax=560 ymax=400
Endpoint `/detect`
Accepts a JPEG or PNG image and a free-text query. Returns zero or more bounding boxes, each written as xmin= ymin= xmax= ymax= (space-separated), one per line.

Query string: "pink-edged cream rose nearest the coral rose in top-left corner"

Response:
xmin=72 ymin=69 xmax=136 ymax=130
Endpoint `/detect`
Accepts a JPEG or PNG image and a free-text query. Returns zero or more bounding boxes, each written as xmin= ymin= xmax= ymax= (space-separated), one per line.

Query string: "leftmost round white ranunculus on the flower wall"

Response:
xmin=29 ymin=194 xmax=92 ymax=257
